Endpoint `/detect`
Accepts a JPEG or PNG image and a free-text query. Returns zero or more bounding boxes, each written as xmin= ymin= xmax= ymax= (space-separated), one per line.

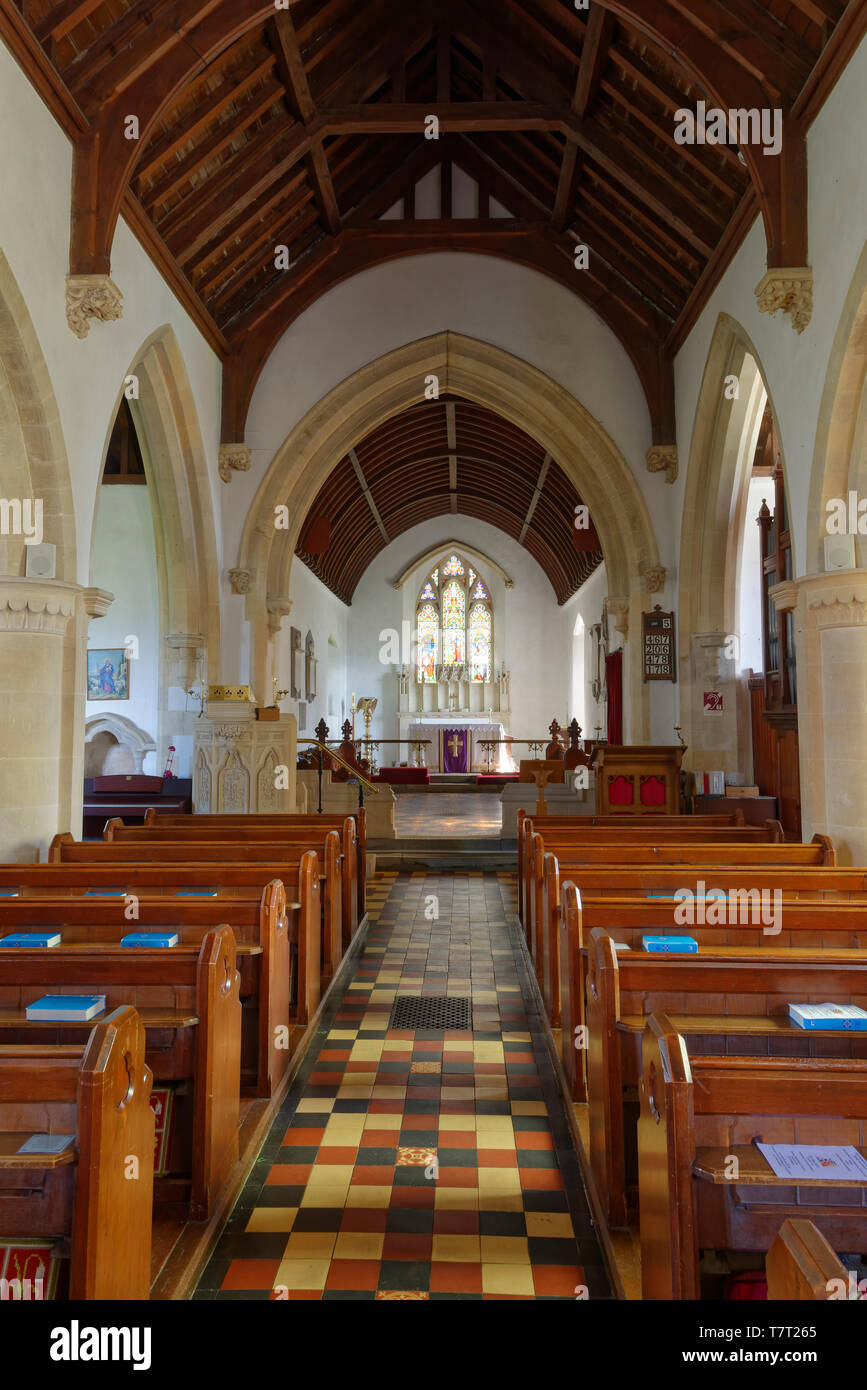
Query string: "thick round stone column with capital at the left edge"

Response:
xmin=0 ymin=575 xmax=78 ymax=862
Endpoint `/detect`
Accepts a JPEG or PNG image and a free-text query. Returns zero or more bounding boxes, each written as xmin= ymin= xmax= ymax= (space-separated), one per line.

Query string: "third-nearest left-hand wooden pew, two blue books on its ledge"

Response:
xmin=0 ymin=872 xmax=312 ymax=1097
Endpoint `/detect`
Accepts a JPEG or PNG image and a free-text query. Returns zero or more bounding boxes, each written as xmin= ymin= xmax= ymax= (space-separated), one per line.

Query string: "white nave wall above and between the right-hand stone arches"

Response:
xmin=670 ymin=39 xmax=867 ymax=575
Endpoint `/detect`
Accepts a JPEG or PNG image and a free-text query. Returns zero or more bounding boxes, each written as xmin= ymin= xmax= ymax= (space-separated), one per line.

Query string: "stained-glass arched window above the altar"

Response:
xmin=415 ymin=555 xmax=493 ymax=682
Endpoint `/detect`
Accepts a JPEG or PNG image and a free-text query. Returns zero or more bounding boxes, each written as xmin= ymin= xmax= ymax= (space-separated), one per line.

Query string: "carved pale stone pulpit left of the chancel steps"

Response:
xmin=193 ymin=699 xmax=297 ymax=815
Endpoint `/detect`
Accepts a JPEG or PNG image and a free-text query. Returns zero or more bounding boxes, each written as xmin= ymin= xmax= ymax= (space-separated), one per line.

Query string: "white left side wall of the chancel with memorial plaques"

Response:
xmin=276 ymin=559 xmax=347 ymax=741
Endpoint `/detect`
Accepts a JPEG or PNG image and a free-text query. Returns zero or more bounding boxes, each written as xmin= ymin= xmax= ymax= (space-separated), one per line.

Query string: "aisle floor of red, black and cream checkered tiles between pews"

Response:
xmin=195 ymin=873 xmax=610 ymax=1300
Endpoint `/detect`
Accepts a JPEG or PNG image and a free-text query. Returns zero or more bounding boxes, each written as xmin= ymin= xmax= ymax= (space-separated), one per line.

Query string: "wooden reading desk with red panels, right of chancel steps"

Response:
xmin=591 ymin=744 xmax=686 ymax=816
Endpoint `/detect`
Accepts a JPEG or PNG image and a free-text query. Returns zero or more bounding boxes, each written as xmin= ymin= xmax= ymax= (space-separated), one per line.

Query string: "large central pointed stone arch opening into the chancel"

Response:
xmin=238 ymin=332 xmax=659 ymax=741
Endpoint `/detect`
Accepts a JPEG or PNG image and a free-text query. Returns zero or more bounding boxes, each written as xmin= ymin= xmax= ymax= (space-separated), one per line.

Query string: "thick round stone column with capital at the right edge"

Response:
xmin=773 ymin=570 xmax=867 ymax=865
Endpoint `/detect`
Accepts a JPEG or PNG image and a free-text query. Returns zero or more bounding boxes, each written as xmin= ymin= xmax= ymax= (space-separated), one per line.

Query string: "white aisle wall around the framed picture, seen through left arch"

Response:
xmin=85 ymin=484 xmax=163 ymax=773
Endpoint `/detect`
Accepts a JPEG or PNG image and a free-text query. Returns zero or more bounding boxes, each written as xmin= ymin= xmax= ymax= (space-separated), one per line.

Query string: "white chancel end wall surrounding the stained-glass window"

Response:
xmin=345 ymin=516 xmax=571 ymax=738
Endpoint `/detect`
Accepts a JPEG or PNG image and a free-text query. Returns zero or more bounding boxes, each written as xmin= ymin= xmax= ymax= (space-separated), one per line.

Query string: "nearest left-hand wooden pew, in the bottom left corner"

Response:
xmin=0 ymin=1006 xmax=154 ymax=1300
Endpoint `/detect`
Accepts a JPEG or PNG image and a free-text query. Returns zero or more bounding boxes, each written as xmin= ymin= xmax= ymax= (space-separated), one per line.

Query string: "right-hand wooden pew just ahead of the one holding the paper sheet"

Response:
xmin=586 ymin=927 xmax=867 ymax=1226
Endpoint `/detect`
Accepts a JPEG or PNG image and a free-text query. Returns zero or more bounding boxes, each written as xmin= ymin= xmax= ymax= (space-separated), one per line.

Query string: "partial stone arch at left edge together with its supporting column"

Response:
xmin=0 ymin=252 xmax=86 ymax=859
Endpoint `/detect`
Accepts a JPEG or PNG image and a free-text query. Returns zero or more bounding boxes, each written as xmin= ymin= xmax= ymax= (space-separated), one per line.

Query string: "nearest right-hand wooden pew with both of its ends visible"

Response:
xmin=527 ymin=833 xmax=835 ymax=1022
